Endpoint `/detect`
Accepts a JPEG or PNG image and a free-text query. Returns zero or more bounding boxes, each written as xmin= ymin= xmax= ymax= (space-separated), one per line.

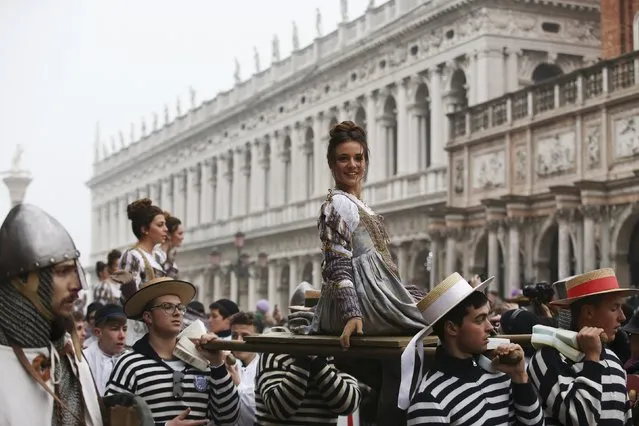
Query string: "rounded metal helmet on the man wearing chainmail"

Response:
xmin=0 ymin=204 xmax=85 ymax=284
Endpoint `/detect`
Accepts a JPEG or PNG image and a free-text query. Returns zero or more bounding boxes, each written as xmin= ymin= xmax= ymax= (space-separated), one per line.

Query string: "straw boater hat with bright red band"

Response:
xmin=551 ymin=268 xmax=639 ymax=306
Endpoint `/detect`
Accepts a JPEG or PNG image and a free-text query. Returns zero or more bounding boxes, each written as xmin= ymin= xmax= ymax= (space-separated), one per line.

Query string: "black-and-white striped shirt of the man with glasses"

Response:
xmin=106 ymin=334 xmax=239 ymax=424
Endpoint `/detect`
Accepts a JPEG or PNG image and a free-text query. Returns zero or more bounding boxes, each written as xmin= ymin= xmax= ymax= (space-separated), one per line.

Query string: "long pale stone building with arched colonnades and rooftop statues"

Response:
xmin=88 ymin=0 xmax=601 ymax=307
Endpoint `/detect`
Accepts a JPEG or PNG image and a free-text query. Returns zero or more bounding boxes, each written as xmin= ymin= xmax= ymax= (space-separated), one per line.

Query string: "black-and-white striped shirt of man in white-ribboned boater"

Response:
xmin=407 ymin=346 xmax=544 ymax=426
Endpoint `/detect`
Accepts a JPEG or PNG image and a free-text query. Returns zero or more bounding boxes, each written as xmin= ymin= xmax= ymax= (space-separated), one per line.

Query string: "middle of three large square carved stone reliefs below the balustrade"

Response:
xmin=537 ymin=131 xmax=575 ymax=177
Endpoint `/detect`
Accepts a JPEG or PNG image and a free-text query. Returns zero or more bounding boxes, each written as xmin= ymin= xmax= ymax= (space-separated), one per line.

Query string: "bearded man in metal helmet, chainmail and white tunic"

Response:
xmin=0 ymin=204 xmax=102 ymax=426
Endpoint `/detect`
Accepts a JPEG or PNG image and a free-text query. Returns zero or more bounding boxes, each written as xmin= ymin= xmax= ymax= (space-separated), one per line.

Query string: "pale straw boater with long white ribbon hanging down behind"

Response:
xmin=397 ymin=272 xmax=495 ymax=410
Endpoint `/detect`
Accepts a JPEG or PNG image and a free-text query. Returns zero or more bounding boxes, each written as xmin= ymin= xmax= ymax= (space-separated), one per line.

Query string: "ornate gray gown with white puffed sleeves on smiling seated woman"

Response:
xmin=310 ymin=190 xmax=426 ymax=336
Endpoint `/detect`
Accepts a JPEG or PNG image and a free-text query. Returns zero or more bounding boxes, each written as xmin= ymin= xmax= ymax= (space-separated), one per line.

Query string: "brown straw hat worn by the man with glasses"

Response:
xmin=124 ymin=277 xmax=195 ymax=319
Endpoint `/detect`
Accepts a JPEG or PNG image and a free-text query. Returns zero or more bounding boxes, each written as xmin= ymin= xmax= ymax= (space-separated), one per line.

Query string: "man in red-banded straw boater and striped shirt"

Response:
xmin=528 ymin=268 xmax=639 ymax=426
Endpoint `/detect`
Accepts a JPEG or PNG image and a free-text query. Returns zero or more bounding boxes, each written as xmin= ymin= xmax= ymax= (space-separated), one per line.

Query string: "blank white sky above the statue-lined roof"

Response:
xmin=0 ymin=0 xmax=370 ymax=260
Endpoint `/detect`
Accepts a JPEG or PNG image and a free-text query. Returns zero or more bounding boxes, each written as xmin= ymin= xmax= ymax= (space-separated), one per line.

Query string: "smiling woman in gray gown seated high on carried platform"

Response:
xmin=311 ymin=121 xmax=426 ymax=425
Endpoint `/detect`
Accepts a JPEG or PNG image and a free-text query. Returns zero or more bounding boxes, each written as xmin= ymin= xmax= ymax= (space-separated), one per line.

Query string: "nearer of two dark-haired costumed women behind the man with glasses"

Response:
xmin=120 ymin=198 xmax=168 ymax=346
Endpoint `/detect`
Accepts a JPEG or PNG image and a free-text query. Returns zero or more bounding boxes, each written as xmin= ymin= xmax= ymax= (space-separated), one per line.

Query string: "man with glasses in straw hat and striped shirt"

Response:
xmin=106 ymin=277 xmax=238 ymax=426
